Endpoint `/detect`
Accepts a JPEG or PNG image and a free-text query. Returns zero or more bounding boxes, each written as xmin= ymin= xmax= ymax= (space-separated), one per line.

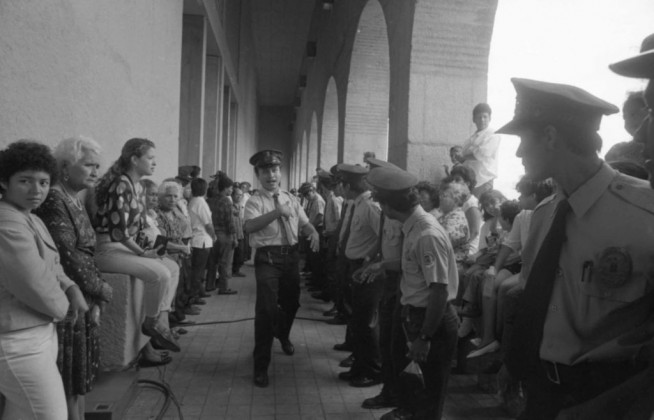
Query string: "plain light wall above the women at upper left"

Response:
xmin=0 ymin=0 xmax=182 ymax=179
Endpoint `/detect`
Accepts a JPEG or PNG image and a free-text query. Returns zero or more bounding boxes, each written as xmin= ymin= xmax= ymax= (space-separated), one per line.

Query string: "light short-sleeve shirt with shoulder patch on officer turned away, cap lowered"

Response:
xmin=400 ymin=206 xmax=459 ymax=308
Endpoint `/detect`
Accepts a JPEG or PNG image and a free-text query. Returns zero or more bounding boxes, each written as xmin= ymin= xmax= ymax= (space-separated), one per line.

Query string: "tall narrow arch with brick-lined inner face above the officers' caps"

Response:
xmin=343 ymin=0 xmax=390 ymax=163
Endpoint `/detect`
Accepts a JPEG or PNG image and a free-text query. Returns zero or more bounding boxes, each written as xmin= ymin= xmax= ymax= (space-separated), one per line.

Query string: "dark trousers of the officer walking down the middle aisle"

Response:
xmin=253 ymin=247 xmax=300 ymax=372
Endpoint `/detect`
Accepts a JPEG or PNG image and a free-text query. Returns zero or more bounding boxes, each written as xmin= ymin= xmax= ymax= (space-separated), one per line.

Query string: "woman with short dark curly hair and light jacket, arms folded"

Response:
xmin=0 ymin=141 xmax=88 ymax=420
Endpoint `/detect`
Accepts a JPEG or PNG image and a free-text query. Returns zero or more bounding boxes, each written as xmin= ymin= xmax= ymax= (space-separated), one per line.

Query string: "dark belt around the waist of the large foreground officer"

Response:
xmin=540 ymin=360 xmax=645 ymax=385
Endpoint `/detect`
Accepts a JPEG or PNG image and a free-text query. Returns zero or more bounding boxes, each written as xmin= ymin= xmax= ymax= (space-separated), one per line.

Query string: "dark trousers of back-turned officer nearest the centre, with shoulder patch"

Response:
xmin=394 ymin=304 xmax=459 ymax=419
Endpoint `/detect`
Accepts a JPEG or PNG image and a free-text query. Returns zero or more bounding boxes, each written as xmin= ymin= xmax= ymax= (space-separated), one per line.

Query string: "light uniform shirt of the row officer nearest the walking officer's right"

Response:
xmin=344 ymin=191 xmax=381 ymax=260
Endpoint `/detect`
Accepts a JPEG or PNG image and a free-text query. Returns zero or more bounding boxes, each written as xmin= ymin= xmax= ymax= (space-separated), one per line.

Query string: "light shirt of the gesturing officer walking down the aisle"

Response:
xmin=245 ymin=188 xmax=309 ymax=248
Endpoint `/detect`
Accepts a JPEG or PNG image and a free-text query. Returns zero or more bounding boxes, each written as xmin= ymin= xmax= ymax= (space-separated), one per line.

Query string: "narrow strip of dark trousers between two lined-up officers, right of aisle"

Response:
xmin=379 ymin=271 xmax=402 ymax=396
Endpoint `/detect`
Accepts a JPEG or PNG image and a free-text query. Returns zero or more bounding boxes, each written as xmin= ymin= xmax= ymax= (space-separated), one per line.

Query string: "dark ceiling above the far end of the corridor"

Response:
xmin=250 ymin=0 xmax=320 ymax=106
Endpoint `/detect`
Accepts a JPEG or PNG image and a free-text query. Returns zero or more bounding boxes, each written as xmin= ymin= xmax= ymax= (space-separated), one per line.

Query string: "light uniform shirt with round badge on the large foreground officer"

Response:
xmin=521 ymin=163 xmax=654 ymax=365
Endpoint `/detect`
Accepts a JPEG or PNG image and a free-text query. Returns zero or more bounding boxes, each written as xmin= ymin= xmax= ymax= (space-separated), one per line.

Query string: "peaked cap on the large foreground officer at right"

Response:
xmin=497 ymin=78 xmax=619 ymax=134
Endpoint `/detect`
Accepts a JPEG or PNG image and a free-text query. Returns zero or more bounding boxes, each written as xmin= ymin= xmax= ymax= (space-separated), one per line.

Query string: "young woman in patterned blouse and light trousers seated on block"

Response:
xmin=95 ymin=138 xmax=180 ymax=351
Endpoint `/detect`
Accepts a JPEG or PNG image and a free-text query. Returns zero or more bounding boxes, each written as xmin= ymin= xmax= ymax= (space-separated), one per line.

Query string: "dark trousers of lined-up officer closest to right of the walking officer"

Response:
xmin=348 ymin=260 xmax=384 ymax=377
